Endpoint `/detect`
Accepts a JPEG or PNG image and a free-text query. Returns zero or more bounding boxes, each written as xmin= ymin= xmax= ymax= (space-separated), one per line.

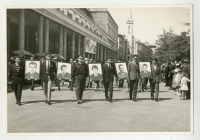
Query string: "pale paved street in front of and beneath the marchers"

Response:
xmin=7 ymin=83 xmax=191 ymax=133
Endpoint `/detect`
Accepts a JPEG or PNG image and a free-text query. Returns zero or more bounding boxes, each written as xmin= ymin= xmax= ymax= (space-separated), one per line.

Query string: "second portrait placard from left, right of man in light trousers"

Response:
xmin=56 ymin=62 xmax=71 ymax=80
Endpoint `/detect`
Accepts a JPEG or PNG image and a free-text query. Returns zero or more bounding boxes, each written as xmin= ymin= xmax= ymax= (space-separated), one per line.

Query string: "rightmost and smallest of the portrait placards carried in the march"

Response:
xmin=139 ymin=62 xmax=151 ymax=78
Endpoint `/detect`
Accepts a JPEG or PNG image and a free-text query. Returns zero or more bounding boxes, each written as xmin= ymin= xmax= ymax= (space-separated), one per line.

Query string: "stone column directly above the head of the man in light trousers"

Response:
xmin=44 ymin=18 xmax=49 ymax=53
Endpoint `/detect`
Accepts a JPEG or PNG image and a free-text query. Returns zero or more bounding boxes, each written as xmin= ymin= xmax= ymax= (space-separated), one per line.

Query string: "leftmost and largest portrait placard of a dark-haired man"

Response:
xmin=25 ymin=60 xmax=40 ymax=80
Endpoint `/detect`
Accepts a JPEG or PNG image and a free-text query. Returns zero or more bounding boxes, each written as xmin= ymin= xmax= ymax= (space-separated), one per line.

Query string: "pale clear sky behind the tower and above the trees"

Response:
xmin=108 ymin=7 xmax=190 ymax=44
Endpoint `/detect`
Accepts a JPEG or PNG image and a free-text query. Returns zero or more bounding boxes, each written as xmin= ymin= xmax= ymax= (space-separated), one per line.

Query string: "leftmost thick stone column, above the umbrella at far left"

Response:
xmin=18 ymin=9 xmax=25 ymax=50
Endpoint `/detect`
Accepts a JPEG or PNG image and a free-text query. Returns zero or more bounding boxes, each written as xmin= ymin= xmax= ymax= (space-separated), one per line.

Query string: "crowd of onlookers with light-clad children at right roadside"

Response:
xmin=161 ymin=59 xmax=190 ymax=99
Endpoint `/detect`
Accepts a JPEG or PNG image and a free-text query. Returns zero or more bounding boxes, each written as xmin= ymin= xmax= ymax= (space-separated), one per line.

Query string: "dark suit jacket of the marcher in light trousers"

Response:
xmin=40 ymin=60 xmax=56 ymax=82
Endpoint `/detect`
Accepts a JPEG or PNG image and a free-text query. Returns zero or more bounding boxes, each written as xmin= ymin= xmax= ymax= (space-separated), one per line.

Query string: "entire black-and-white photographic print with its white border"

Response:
xmin=2 ymin=3 xmax=194 ymax=136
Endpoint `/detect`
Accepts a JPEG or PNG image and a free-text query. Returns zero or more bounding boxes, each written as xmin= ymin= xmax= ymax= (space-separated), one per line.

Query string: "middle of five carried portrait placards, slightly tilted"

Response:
xmin=88 ymin=63 xmax=103 ymax=81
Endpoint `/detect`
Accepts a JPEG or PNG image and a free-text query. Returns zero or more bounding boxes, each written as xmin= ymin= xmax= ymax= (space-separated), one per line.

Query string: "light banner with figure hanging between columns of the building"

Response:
xmin=85 ymin=37 xmax=97 ymax=54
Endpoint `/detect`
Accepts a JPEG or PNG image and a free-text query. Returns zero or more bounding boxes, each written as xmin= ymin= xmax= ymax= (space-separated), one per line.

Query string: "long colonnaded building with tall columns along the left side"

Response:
xmin=7 ymin=8 xmax=117 ymax=61
